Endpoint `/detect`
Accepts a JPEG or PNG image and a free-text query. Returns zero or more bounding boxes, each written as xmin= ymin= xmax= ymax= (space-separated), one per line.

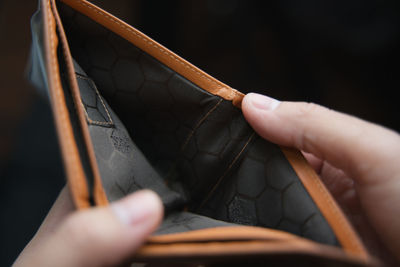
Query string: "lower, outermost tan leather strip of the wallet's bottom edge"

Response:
xmin=135 ymin=239 xmax=374 ymax=266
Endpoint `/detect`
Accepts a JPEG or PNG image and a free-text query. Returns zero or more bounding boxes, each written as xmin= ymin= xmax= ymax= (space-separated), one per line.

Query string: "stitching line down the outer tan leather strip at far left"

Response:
xmin=46 ymin=0 xmax=79 ymax=194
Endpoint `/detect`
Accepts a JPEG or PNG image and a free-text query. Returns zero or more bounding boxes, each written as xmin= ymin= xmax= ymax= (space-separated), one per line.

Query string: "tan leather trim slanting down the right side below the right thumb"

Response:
xmin=281 ymin=147 xmax=369 ymax=258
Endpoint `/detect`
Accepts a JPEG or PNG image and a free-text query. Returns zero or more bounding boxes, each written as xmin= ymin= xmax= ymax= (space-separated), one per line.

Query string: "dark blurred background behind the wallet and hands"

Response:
xmin=0 ymin=0 xmax=400 ymax=266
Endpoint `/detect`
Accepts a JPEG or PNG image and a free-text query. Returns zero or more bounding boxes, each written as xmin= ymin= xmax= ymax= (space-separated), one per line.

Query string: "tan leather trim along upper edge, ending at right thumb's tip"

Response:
xmin=61 ymin=0 xmax=243 ymax=107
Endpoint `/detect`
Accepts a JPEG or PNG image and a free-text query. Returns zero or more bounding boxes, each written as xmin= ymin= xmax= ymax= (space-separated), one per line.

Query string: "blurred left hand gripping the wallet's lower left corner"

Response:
xmin=14 ymin=188 xmax=163 ymax=267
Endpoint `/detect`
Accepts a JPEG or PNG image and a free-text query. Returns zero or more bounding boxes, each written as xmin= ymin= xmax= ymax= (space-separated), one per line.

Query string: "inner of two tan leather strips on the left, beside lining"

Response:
xmin=50 ymin=0 xmax=108 ymax=206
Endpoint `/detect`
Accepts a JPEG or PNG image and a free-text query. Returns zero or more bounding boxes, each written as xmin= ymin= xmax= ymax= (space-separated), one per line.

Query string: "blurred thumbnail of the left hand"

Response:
xmin=111 ymin=190 xmax=162 ymax=225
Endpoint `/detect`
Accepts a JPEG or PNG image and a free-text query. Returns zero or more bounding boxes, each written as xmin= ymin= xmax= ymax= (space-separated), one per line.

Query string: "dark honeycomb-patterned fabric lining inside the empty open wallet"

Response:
xmin=60 ymin=4 xmax=338 ymax=245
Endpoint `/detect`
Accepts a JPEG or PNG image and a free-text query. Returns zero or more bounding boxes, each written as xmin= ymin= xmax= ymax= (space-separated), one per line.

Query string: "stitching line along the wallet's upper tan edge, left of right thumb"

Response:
xmin=74 ymin=0 xmax=233 ymax=93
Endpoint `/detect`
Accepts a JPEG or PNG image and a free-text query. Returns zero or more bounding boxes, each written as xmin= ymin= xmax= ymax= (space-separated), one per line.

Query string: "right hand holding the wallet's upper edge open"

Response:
xmin=242 ymin=94 xmax=400 ymax=264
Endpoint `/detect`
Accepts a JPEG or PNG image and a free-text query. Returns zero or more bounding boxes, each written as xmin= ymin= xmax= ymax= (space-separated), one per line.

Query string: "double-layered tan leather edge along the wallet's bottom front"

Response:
xmin=134 ymin=226 xmax=373 ymax=266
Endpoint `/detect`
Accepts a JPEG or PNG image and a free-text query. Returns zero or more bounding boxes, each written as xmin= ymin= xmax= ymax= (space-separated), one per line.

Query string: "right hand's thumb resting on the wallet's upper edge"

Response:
xmin=242 ymin=94 xmax=400 ymax=184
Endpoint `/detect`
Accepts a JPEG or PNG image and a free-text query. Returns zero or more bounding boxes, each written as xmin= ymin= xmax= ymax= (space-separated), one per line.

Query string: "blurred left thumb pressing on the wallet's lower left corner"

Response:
xmin=34 ymin=190 xmax=163 ymax=266
